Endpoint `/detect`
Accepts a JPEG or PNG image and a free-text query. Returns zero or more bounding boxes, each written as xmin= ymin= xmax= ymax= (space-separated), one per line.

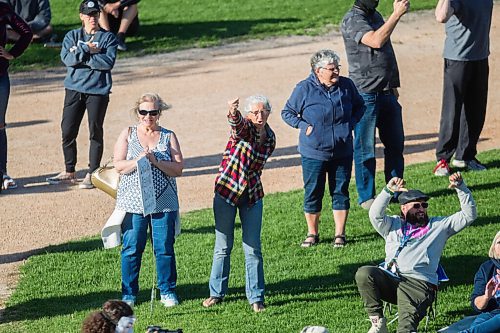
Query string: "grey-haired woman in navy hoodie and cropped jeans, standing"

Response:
xmin=281 ymin=50 xmax=364 ymax=247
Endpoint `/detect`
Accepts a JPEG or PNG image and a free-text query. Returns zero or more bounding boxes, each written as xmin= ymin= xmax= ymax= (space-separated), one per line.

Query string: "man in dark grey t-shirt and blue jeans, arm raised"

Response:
xmin=341 ymin=0 xmax=410 ymax=209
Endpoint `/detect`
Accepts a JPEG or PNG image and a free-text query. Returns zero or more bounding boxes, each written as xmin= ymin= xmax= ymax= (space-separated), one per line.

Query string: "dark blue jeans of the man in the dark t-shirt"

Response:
xmin=354 ymin=92 xmax=404 ymax=203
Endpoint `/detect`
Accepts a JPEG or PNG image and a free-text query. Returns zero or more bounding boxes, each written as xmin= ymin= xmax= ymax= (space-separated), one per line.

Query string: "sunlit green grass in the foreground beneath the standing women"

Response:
xmin=0 ymin=150 xmax=500 ymax=333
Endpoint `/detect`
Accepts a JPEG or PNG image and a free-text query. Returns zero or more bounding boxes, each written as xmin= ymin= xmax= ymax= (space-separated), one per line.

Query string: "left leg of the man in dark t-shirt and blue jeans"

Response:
xmin=354 ymin=93 xmax=378 ymax=209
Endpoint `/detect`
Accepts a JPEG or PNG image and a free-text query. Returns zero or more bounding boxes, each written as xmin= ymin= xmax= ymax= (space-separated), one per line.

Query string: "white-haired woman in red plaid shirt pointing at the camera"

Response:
xmin=203 ymin=95 xmax=276 ymax=312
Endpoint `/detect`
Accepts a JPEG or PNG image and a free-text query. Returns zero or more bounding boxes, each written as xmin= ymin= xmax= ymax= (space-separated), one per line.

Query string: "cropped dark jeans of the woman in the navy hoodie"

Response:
xmin=301 ymin=156 xmax=352 ymax=214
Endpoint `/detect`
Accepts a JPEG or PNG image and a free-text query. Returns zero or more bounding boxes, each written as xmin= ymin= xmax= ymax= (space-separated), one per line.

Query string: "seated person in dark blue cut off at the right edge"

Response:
xmin=462 ymin=231 xmax=500 ymax=333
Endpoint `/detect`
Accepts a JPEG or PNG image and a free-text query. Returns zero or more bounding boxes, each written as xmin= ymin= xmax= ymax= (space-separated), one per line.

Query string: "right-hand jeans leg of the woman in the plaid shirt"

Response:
xmin=238 ymin=195 xmax=265 ymax=312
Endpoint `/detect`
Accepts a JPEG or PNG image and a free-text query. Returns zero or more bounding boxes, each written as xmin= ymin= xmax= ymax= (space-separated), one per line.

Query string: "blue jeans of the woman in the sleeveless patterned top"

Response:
xmin=122 ymin=212 xmax=177 ymax=300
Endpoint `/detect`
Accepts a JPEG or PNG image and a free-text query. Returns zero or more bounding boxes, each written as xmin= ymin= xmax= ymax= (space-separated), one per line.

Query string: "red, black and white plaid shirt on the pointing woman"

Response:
xmin=215 ymin=111 xmax=276 ymax=206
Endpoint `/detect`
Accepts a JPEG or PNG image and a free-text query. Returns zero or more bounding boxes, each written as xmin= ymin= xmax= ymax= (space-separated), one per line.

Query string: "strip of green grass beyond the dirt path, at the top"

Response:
xmin=11 ymin=0 xmax=435 ymax=71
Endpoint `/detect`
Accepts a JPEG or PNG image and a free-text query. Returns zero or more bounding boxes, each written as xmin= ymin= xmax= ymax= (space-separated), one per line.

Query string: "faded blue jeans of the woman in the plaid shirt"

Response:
xmin=209 ymin=194 xmax=264 ymax=304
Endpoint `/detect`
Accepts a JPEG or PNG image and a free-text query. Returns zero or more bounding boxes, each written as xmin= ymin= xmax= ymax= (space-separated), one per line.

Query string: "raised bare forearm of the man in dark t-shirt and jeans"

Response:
xmin=361 ymin=0 xmax=410 ymax=49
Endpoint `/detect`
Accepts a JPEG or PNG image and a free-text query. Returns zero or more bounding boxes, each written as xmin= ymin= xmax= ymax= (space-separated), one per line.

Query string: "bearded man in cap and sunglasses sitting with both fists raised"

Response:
xmin=356 ymin=172 xmax=477 ymax=333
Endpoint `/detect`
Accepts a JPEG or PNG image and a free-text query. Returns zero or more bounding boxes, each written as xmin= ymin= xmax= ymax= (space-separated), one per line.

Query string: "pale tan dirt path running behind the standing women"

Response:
xmin=0 ymin=6 xmax=500 ymax=307
